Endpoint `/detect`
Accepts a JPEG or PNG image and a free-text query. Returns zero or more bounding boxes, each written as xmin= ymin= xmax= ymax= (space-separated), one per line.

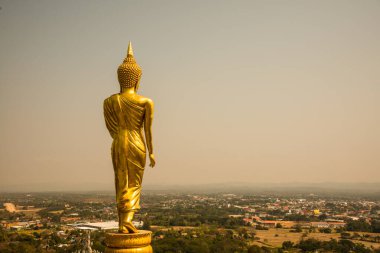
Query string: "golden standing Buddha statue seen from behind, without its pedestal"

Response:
xmin=103 ymin=42 xmax=156 ymax=233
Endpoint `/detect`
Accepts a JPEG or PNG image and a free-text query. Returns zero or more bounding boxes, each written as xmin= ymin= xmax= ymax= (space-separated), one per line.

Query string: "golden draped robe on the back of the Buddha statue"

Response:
xmin=104 ymin=94 xmax=146 ymax=212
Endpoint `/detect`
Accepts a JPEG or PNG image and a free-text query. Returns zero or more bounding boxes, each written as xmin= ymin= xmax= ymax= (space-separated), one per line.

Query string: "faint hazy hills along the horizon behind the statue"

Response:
xmin=0 ymin=182 xmax=380 ymax=196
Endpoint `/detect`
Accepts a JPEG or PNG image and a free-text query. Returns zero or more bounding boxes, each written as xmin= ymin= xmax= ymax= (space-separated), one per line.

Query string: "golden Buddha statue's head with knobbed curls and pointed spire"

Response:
xmin=117 ymin=42 xmax=142 ymax=91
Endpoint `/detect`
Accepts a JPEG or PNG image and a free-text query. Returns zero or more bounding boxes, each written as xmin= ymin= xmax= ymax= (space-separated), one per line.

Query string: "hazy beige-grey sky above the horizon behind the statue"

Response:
xmin=0 ymin=0 xmax=380 ymax=191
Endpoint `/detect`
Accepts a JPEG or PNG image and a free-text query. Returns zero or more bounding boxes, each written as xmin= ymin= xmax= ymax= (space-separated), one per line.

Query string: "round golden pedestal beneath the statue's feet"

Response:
xmin=105 ymin=230 xmax=153 ymax=253
